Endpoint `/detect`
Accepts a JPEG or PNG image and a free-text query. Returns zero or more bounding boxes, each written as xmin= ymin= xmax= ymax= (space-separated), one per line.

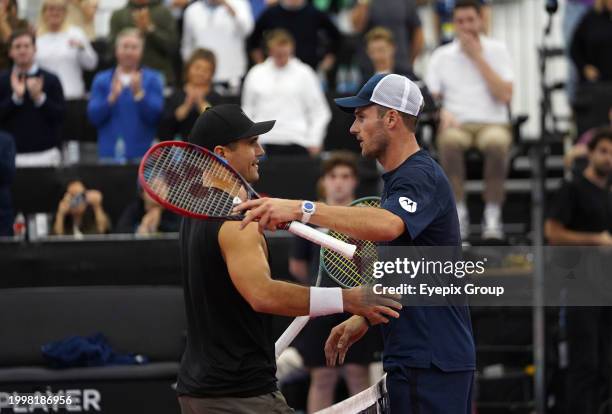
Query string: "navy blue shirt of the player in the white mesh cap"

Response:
xmin=381 ymin=150 xmax=476 ymax=371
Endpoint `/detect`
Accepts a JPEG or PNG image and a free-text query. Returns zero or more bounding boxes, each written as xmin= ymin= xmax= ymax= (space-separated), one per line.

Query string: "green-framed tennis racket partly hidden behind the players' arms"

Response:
xmin=275 ymin=197 xmax=380 ymax=358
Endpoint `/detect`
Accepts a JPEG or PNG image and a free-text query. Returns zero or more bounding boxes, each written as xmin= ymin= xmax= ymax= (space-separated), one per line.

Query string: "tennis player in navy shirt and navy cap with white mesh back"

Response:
xmin=238 ymin=74 xmax=476 ymax=414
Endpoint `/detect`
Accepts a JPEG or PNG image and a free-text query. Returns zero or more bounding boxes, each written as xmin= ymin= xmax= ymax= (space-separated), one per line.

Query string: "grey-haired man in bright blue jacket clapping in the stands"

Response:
xmin=87 ymin=29 xmax=164 ymax=162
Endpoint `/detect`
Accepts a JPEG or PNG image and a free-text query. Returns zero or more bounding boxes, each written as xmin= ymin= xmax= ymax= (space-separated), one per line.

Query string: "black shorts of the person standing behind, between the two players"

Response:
xmin=293 ymin=313 xmax=383 ymax=368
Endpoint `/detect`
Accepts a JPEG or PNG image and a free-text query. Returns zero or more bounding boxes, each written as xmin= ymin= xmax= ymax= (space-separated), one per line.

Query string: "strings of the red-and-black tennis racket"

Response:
xmin=143 ymin=146 xmax=244 ymax=217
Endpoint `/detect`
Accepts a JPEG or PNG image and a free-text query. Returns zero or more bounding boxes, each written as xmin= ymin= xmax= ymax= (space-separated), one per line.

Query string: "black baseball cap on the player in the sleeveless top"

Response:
xmin=189 ymin=104 xmax=276 ymax=151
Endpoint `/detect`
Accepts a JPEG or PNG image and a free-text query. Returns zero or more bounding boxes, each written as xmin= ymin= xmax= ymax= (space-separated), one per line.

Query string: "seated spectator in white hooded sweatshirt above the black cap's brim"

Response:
xmin=242 ymin=29 xmax=331 ymax=156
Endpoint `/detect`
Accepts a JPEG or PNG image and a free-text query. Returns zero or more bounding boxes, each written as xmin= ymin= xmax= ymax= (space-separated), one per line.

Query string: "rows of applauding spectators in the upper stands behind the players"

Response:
xmin=0 ymin=0 xmax=612 ymax=238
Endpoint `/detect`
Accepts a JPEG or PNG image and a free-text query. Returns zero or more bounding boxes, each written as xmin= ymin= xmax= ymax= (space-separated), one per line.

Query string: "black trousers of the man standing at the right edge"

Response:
xmin=566 ymin=307 xmax=612 ymax=414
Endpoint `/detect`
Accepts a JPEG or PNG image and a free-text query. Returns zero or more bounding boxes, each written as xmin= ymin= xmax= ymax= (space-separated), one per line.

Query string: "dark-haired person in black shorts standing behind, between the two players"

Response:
xmin=289 ymin=152 xmax=380 ymax=413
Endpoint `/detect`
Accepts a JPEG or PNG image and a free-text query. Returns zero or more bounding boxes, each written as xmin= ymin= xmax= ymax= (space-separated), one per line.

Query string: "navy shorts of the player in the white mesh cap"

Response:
xmin=385 ymin=366 xmax=474 ymax=414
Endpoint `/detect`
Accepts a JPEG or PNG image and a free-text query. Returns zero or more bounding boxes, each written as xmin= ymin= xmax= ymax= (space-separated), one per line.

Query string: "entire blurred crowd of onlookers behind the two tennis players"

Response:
xmin=0 ymin=0 xmax=612 ymax=412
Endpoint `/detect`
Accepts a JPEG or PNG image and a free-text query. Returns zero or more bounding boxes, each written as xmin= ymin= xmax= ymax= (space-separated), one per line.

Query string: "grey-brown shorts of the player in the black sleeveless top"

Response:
xmin=179 ymin=391 xmax=293 ymax=414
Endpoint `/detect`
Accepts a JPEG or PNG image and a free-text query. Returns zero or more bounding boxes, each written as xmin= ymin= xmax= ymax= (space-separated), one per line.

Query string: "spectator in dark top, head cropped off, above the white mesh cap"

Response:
xmin=353 ymin=0 xmax=425 ymax=74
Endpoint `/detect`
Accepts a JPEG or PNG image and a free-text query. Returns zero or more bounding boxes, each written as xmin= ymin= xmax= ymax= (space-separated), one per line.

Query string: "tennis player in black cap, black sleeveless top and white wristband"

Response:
xmin=177 ymin=105 xmax=401 ymax=414
